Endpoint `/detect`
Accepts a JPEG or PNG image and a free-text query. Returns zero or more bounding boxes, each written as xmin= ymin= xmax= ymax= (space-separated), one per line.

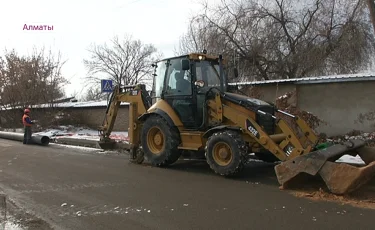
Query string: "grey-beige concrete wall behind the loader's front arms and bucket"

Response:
xmin=242 ymin=81 xmax=375 ymax=136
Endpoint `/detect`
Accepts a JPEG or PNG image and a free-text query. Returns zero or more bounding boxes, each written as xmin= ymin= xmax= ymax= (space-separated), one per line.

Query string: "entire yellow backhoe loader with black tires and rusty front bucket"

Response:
xmin=99 ymin=52 xmax=375 ymax=194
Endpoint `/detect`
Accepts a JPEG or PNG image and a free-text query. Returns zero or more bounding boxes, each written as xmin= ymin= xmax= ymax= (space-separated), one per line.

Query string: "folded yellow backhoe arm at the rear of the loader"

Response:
xmin=98 ymin=84 xmax=151 ymax=158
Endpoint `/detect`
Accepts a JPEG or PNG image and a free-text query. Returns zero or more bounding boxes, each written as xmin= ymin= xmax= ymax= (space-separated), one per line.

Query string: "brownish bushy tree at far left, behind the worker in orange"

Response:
xmin=0 ymin=48 xmax=68 ymax=126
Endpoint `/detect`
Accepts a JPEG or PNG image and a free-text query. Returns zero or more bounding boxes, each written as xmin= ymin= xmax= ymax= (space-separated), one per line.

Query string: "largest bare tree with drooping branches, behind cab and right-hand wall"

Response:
xmin=180 ymin=0 xmax=374 ymax=80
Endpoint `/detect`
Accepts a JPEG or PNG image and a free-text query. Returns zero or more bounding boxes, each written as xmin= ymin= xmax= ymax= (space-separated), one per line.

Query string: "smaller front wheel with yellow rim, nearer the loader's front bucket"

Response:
xmin=205 ymin=131 xmax=248 ymax=176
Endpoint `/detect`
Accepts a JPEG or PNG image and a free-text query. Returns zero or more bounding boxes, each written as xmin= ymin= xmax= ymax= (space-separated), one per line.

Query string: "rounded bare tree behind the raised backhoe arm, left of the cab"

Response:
xmin=84 ymin=35 xmax=160 ymax=88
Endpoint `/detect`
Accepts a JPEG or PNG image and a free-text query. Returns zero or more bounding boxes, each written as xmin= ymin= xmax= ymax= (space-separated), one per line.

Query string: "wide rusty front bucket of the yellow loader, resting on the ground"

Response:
xmin=275 ymin=140 xmax=375 ymax=195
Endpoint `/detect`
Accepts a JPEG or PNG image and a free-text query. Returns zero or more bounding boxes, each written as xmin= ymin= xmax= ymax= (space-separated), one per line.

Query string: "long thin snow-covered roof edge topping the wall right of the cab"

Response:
xmin=229 ymin=73 xmax=375 ymax=85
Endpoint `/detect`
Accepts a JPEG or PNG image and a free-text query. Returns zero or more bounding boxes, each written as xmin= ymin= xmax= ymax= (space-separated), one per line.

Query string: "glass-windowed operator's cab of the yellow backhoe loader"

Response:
xmin=152 ymin=54 xmax=227 ymax=130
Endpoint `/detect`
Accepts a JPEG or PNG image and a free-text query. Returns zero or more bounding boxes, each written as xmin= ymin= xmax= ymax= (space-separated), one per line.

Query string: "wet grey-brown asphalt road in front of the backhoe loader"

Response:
xmin=0 ymin=140 xmax=375 ymax=230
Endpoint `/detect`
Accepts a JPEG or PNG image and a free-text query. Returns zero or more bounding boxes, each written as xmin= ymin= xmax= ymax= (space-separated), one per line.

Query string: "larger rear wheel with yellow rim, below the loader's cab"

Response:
xmin=141 ymin=115 xmax=181 ymax=167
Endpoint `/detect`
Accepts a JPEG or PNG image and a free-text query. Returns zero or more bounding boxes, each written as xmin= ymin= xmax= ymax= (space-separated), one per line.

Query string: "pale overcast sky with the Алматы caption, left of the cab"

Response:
xmin=0 ymin=0 xmax=209 ymax=99
